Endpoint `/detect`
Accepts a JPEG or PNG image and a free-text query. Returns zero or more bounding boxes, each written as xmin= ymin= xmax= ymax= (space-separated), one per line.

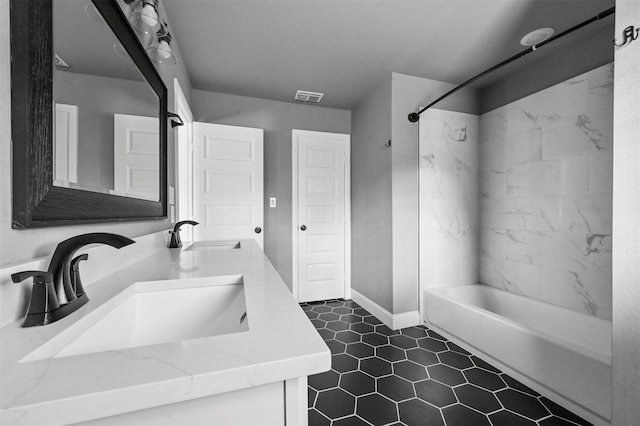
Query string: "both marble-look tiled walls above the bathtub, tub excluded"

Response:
xmin=419 ymin=64 xmax=613 ymax=320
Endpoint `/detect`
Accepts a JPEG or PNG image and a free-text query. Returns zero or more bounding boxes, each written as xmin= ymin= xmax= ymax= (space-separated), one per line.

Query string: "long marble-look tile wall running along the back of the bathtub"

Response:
xmin=478 ymin=64 xmax=613 ymax=319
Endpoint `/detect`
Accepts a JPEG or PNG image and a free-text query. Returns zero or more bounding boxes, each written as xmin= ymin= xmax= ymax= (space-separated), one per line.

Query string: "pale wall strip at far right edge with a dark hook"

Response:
xmin=612 ymin=0 xmax=640 ymax=425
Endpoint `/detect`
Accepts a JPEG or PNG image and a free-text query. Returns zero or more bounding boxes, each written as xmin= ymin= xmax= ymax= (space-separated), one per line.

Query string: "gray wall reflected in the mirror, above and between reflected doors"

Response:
xmin=53 ymin=70 xmax=159 ymax=189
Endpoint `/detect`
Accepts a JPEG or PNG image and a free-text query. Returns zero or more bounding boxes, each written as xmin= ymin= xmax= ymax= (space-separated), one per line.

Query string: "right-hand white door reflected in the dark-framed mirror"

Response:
xmin=113 ymin=114 xmax=160 ymax=201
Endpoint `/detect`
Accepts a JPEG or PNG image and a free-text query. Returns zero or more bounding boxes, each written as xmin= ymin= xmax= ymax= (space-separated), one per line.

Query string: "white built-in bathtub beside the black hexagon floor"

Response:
xmin=423 ymin=284 xmax=611 ymax=424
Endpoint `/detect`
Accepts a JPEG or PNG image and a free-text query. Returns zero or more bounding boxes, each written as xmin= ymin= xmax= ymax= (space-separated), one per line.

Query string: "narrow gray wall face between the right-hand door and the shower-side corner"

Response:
xmin=351 ymin=80 xmax=393 ymax=312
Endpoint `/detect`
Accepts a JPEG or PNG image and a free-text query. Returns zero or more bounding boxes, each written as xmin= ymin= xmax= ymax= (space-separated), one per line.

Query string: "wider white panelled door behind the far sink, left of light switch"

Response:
xmin=193 ymin=123 xmax=264 ymax=248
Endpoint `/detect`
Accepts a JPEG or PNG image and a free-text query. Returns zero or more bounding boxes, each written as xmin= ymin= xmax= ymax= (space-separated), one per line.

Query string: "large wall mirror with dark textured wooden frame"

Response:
xmin=11 ymin=0 xmax=167 ymax=229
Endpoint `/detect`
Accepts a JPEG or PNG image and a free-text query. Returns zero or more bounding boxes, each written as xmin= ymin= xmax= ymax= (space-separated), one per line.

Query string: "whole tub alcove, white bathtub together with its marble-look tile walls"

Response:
xmin=419 ymin=64 xmax=613 ymax=424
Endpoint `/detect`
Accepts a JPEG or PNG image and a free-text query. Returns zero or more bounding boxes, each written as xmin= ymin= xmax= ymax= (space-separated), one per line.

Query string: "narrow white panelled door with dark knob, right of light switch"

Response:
xmin=293 ymin=130 xmax=349 ymax=302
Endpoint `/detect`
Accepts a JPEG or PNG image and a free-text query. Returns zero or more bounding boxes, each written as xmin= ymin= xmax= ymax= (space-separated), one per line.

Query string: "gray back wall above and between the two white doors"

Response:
xmin=191 ymin=90 xmax=351 ymax=288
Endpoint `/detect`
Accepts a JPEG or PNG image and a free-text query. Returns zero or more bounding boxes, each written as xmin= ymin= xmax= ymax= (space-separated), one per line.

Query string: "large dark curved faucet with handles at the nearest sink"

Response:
xmin=11 ymin=232 xmax=135 ymax=327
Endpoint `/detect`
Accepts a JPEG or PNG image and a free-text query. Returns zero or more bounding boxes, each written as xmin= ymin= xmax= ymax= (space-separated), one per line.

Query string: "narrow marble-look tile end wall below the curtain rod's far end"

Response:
xmin=419 ymin=109 xmax=480 ymax=288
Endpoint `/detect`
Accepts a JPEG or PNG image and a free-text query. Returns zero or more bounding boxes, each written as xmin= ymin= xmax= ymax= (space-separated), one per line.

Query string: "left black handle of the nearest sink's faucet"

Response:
xmin=11 ymin=271 xmax=60 ymax=327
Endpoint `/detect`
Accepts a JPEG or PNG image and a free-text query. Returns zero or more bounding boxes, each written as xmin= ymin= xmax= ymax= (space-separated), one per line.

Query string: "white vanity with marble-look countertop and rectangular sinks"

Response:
xmin=0 ymin=238 xmax=331 ymax=426
